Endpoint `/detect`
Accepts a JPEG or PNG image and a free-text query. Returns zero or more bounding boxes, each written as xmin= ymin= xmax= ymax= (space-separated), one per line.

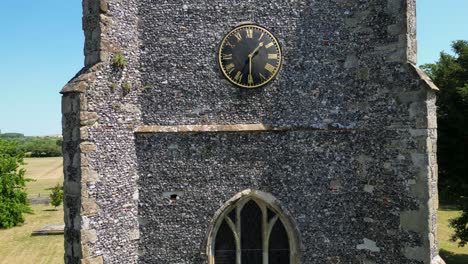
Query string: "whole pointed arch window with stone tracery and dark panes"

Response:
xmin=207 ymin=189 xmax=300 ymax=264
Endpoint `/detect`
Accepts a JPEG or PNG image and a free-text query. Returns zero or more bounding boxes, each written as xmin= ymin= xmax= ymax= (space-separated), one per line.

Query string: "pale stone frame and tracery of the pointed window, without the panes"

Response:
xmin=206 ymin=189 xmax=303 ymax=264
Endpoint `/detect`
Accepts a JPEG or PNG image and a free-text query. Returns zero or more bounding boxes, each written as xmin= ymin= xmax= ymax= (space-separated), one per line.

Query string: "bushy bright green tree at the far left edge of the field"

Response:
xmin=0 ymin=139 xmax=32 ymax=228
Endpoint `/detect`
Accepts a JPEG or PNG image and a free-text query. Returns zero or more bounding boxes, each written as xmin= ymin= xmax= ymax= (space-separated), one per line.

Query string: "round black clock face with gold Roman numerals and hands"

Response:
xmin=218 ymin=25 xmax=282 ymax=88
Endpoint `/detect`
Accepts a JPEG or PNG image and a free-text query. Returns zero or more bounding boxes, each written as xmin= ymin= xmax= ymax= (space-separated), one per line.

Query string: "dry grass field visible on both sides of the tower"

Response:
xmin=0 ymin=158 xmax=468 ymax=264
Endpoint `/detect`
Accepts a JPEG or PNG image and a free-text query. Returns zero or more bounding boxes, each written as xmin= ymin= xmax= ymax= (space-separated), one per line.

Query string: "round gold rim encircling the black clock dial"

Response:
xmin=218 ymin=23 xmax=283 ymax=89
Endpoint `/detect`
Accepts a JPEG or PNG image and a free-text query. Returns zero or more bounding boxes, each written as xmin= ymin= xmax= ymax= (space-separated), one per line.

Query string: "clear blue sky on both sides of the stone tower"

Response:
xmin=0 ymin=0 xmax=468 ymax=135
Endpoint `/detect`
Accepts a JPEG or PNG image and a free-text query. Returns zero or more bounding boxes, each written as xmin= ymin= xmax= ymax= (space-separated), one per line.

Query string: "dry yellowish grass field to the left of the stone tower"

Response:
xmin=0 ymin=157 xmax=64 ymax=264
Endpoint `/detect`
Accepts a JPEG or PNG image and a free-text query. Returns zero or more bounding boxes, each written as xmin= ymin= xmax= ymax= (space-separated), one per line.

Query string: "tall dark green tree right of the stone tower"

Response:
xmin=422 ymin=40 xmax=468 ymax=246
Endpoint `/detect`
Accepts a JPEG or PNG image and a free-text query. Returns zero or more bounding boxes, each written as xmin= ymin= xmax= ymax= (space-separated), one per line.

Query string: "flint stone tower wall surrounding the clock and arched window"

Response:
xmin=62 ymin=0 xmax=443 ymax=264
